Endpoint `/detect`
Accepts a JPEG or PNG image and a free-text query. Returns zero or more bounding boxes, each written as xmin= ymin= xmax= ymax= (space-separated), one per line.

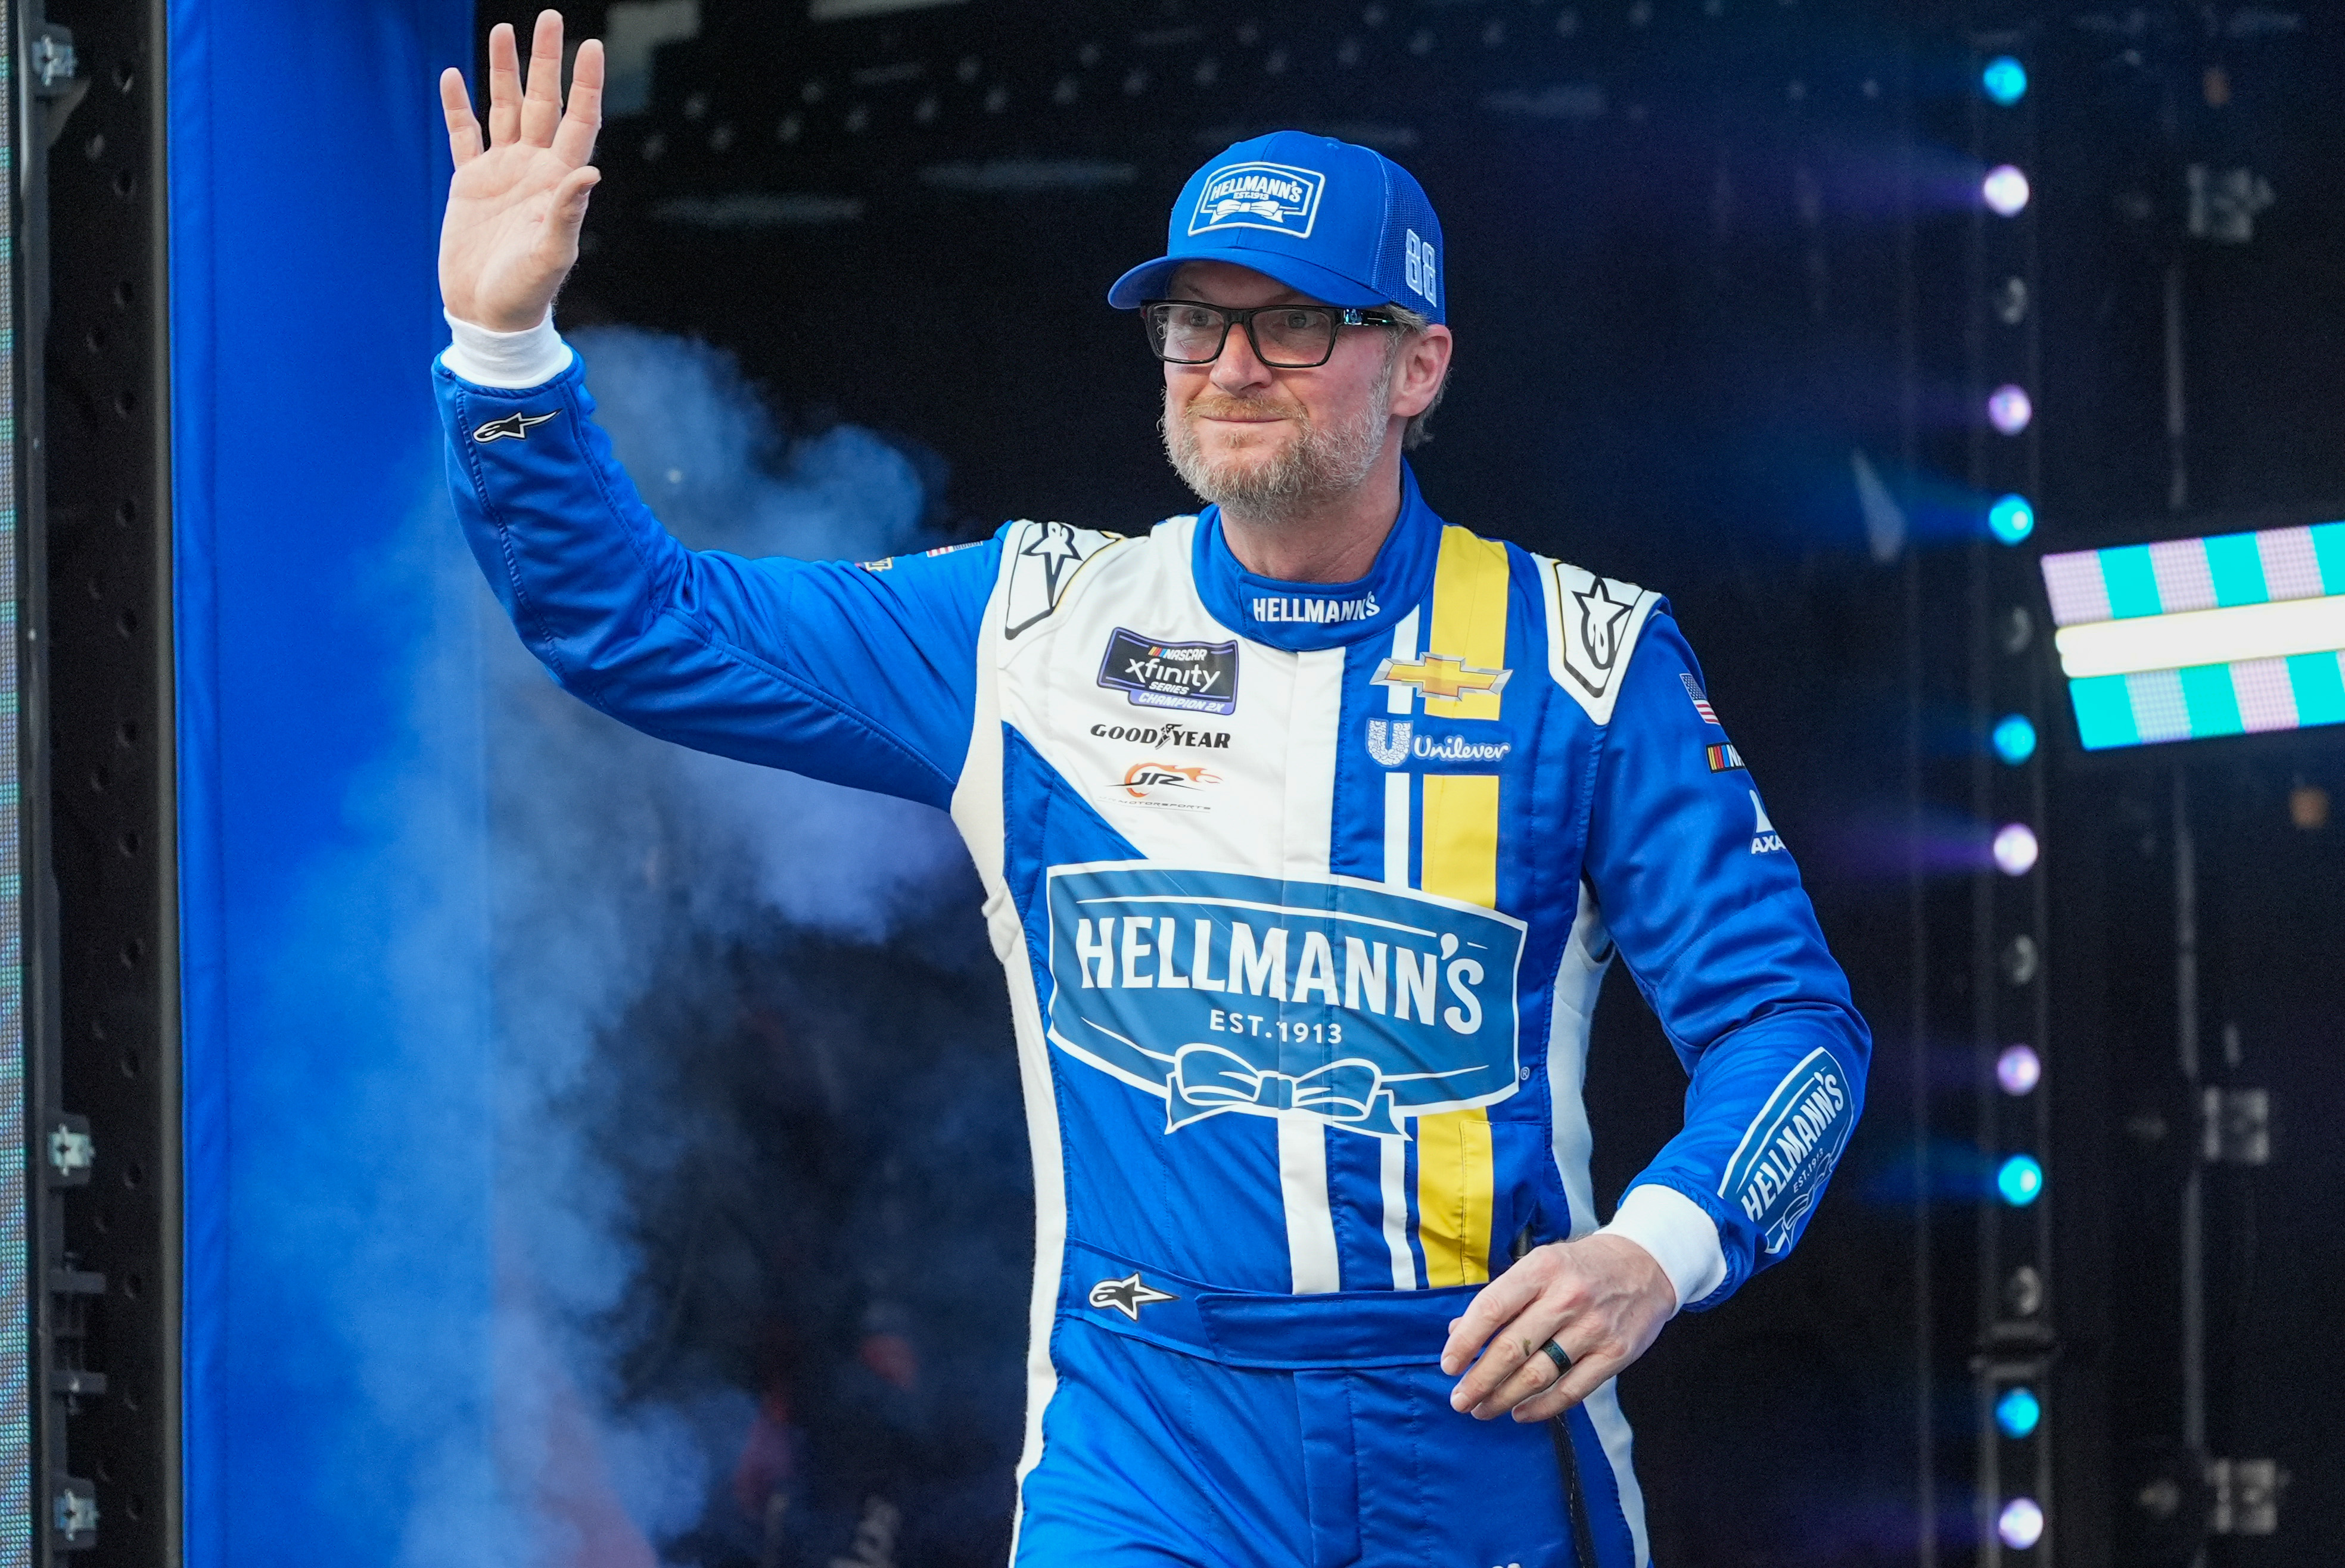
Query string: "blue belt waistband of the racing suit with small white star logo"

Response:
xmin=1058 ymin=1237 xmax=1480 ymax=1371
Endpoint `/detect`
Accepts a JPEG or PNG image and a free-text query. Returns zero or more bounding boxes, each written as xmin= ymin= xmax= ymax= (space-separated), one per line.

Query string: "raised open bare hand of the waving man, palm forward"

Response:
xmin=441 ymin=12 xmax=603 ymax=333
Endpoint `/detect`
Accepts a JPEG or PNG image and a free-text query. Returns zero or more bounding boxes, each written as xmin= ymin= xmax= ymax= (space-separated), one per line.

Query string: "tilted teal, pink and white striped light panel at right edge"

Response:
xmin=2042 ymin=522 xmax=2345 ymax=750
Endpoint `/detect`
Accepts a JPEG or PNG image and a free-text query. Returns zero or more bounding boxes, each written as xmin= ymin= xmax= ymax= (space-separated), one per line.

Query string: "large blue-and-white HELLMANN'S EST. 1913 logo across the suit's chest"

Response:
xmin=1048 ymin=860 xmax=1524 ymax=1137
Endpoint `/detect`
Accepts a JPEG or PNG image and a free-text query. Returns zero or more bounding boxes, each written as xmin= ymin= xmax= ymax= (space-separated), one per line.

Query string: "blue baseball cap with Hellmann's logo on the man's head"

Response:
xmin=1107 ymin=131 xmax=1447 ymax=321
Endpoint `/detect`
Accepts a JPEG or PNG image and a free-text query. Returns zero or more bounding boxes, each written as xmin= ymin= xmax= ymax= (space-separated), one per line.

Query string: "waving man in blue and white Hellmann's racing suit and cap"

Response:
xmin=438 ymin=12 xmax=1871 ymax=1568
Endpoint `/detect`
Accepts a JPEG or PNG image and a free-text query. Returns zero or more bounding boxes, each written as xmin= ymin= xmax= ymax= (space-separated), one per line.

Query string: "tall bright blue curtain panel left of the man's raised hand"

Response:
xmin=173 ymin=0 xmax=499 ymax=1568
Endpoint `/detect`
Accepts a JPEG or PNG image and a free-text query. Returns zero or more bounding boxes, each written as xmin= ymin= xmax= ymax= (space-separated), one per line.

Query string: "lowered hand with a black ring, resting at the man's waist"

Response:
xmin=1442 ymin=1233 xmax=1677 ymax=1420
